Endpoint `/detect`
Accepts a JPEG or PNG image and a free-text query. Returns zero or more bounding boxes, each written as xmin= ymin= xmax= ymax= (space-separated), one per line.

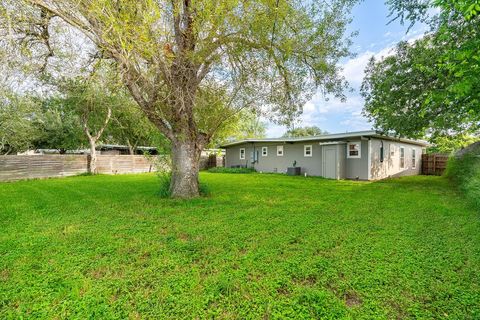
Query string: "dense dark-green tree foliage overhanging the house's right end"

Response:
xmin=362 ymin=0 xmax=480 ymax=141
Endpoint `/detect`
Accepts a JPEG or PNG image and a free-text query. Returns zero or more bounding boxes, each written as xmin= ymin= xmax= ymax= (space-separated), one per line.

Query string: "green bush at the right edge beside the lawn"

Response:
xmin=446 ymin=148 xmax=480 ymax=209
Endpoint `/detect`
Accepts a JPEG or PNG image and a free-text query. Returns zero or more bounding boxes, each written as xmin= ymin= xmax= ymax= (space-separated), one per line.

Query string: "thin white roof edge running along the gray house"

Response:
xmin=220 ymin=130 xmax=429 ymax=149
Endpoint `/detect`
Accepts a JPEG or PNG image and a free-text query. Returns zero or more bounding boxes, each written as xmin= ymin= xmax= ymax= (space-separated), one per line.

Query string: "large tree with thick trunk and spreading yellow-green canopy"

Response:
xmin=2 ymin=0 xmax=357 ymax=197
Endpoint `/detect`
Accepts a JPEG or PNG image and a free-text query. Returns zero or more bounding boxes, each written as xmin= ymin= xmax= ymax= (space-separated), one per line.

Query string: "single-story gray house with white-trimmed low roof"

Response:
xmin=222 ymin=131 xmax=427 ymax=180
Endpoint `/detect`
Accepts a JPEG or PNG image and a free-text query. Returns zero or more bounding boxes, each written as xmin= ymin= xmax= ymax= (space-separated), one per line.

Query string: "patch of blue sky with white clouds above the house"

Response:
xmin=267 ymin=0 xmax=426 ymax=137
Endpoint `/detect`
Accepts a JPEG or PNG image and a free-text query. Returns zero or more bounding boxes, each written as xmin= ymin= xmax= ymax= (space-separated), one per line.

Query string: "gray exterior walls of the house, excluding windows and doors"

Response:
xmin=225 ymin=138 xmax=422 ymax=180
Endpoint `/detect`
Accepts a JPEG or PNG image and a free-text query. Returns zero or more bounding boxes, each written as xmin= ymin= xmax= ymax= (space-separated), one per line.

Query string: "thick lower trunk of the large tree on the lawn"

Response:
xmin=170 ymin=141 xmax=201 ymax=199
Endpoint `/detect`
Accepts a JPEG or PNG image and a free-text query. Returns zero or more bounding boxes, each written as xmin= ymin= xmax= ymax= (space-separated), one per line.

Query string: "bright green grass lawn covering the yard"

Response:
xmin=0 ymin=173 xmax=480 ymax=319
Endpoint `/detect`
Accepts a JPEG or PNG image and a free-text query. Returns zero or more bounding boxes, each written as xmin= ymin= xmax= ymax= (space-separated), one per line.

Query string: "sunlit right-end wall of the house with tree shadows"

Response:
xmin=370 ymin=139 xmax=423 ymax=180
